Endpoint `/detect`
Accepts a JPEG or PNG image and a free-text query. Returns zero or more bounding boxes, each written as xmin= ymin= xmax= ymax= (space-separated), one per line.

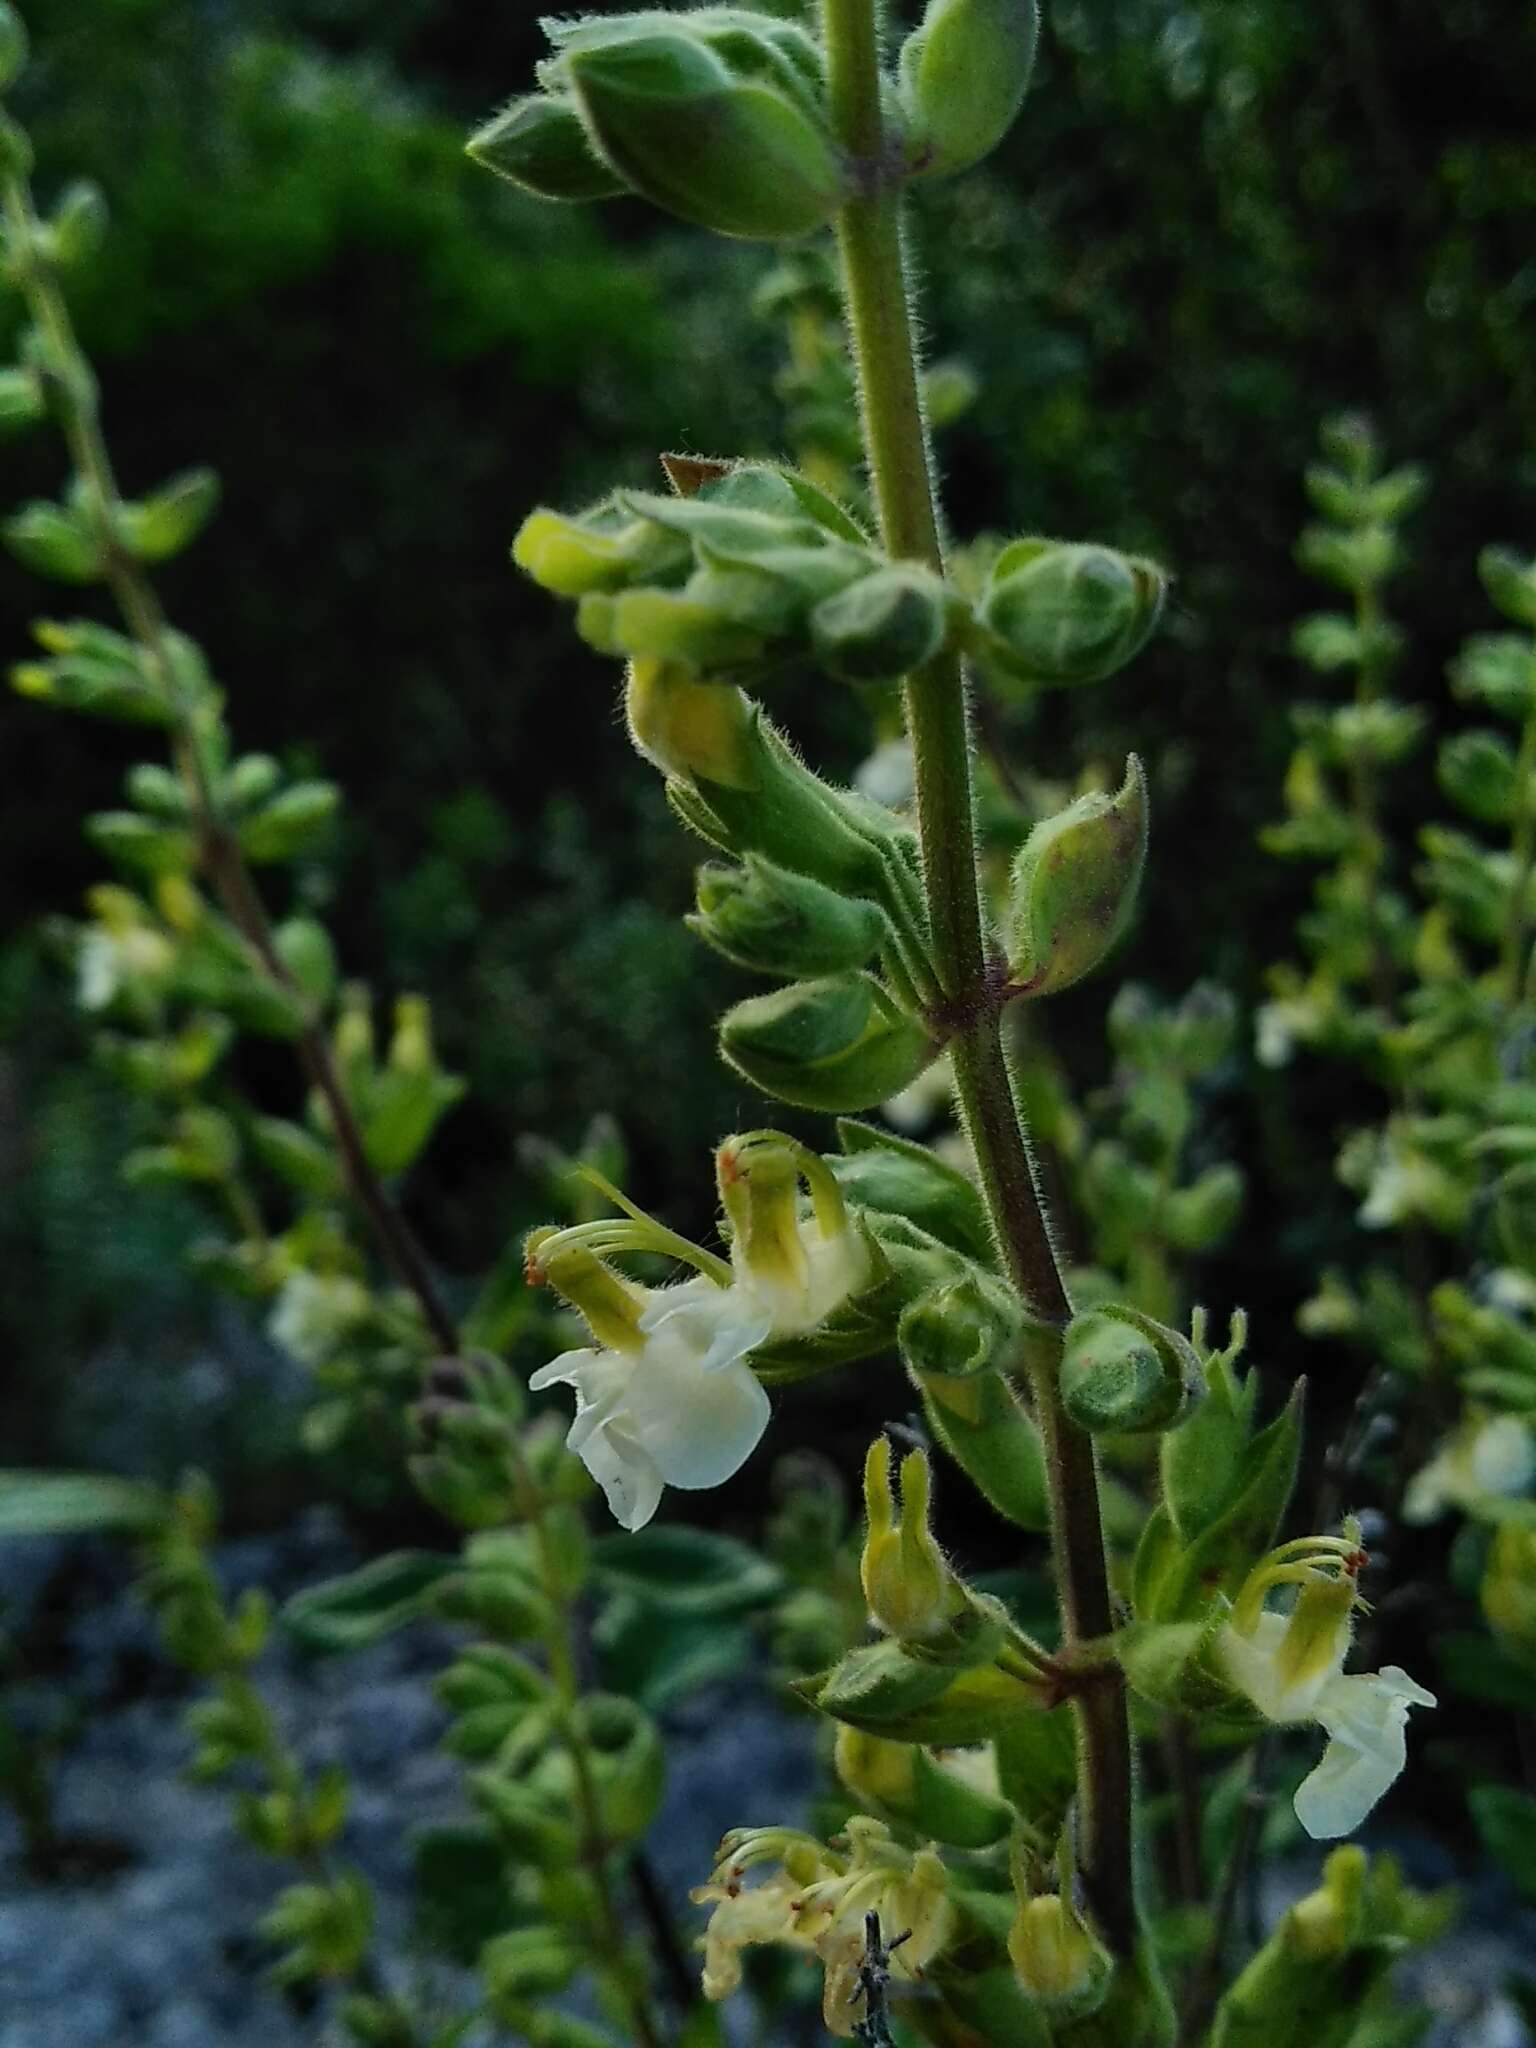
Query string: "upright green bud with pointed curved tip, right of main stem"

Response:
xmin=1006 ymin=754 xmax=1147 ymax=995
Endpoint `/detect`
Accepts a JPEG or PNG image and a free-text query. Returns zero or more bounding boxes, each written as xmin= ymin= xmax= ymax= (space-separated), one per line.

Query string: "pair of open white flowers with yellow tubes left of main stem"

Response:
xmin=526 ymin=1133 xmax=868 ymax=1530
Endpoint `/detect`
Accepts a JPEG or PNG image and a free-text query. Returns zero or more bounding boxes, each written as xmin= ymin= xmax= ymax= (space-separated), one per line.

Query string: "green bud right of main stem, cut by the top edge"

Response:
xmin=899 ymin=0 xmax=1040 ymax=178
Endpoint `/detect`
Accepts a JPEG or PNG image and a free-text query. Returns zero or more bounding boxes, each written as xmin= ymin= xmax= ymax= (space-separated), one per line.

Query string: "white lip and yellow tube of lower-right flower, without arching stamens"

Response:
xmin=1217 ymin=1581 xmax=1436 ymax=1841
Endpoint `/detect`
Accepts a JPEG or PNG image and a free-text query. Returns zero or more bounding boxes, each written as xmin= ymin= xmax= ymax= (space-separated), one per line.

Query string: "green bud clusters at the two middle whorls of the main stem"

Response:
xmin=514 ymin=459 xmax=1161 ymax=1112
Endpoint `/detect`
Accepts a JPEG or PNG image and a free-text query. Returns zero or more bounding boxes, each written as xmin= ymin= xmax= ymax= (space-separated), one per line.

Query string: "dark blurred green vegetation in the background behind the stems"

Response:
xmin=0 ymin=0 xmax=1536 ymax=1511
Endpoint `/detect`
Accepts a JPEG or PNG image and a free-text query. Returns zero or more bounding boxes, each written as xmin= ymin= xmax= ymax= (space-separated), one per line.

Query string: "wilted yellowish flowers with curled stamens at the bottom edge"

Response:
xmin=692 ymin=1815 xmax=954 ymax=2040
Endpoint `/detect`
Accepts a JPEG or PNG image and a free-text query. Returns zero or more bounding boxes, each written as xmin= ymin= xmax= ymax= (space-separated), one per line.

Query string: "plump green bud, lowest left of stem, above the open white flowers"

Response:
xmin=721 ymin=975 xmax=934 ymax=1112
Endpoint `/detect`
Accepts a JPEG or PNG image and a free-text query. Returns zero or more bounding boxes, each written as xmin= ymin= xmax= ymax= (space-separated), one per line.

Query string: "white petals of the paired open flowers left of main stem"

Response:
xmin=528 ymin=1274 xmax=772 ymax=1530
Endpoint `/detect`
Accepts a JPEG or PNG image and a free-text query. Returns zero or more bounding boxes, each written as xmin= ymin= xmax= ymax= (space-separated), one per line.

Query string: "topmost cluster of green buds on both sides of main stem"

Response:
xmin=469 ymin=0 xmax=1036 ymax=242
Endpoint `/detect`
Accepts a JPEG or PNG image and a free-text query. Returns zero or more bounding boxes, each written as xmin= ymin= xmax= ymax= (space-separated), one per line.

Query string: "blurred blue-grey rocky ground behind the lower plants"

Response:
xmin=0 ymin=1516 xmax=1536 ymax=2048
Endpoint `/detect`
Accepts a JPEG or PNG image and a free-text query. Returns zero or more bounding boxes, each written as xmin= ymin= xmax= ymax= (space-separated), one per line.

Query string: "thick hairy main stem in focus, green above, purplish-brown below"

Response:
xmin=823 ymin=0 xmax=1137 ymax=1954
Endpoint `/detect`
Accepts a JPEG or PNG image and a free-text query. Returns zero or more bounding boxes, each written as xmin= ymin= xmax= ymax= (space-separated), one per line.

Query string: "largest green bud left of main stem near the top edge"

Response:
xmin=559 ymin=28 xmax=846 ymax=242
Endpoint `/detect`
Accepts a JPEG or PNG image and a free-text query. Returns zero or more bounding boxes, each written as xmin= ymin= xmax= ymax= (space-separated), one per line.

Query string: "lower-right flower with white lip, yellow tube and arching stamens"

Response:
xmin=1217 ymin=1524 xmax=1436 ymax=1841
